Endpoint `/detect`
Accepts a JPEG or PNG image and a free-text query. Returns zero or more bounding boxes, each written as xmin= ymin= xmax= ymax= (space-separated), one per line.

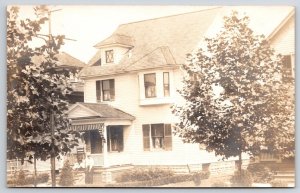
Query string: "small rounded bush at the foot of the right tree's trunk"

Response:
xmin=230 ymin=170 xmax=253 ymax=187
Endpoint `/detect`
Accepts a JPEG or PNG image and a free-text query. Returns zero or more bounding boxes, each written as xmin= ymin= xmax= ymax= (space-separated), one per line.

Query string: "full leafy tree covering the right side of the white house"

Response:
xmin=173 ymin=12 xmax=295 ymax=171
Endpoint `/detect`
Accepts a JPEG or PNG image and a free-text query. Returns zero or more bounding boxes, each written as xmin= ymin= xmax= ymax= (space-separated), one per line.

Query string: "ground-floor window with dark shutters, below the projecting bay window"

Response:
xmin=143 ymin=124 xmax=172 ymax=151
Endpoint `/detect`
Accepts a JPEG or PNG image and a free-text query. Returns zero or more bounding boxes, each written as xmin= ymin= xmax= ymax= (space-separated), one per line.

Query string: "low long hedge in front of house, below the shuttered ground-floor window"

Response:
xmin=116 ymin=168 xmax=174 ymax=182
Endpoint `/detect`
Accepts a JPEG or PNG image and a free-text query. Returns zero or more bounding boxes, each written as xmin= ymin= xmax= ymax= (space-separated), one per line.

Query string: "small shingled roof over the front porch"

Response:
xmin=69 ymin=102 xmax=135 ymax=120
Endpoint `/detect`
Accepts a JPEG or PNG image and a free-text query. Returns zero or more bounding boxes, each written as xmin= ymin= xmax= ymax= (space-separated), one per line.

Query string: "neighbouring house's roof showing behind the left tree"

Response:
xmin=32 ymin=52 xmax=86 ymax=69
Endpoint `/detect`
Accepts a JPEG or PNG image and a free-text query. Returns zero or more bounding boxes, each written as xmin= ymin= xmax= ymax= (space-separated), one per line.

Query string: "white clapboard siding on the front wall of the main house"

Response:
xmin=85 ymin=69 xmax=227 ymax=165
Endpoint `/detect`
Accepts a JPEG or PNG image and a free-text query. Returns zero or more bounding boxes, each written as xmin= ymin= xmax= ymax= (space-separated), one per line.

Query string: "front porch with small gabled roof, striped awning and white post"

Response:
xmin=68 ymin=103 xmax=134 ymax=168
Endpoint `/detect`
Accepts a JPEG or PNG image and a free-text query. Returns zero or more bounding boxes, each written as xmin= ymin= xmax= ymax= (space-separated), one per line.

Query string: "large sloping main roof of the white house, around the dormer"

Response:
xmin=80 ymin=8 xmax=220 ymax=77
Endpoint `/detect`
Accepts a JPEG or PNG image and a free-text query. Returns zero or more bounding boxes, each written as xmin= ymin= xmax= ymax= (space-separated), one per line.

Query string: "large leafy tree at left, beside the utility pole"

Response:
xmin=7 ymin=6 xmax=78 ymax=185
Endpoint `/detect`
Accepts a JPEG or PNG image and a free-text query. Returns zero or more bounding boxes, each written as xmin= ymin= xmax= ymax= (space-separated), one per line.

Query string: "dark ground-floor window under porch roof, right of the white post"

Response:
xmin=107 ymin=126 xmax=123 ymax=152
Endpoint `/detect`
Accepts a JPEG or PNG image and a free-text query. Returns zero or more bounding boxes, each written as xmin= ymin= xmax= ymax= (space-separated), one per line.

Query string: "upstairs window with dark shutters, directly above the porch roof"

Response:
xmin=96 ymin=79 xmax=115 ymax=102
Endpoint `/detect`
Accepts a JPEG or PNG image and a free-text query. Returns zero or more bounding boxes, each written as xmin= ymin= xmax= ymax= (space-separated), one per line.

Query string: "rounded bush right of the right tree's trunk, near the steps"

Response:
xmin=247 ymin=163 xmax=275 ymax=183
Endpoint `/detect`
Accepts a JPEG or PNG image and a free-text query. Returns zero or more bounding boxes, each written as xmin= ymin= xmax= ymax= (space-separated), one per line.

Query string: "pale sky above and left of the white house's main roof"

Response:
xmin=14 ymin=5 xmax=214 ymax=63
